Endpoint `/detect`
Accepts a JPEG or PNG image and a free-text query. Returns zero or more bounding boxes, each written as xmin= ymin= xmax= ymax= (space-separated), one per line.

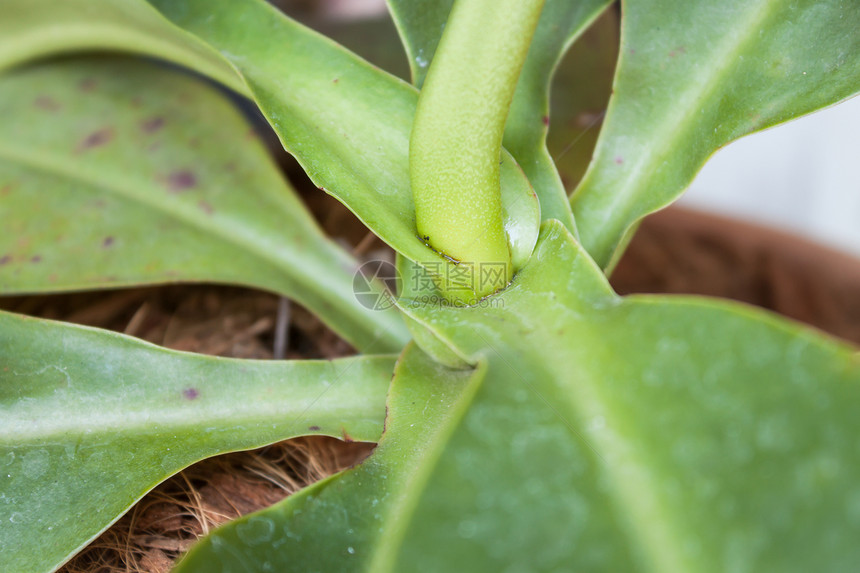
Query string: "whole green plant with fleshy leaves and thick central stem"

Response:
xmin=0 ymin=0 xmax=860 ymax=572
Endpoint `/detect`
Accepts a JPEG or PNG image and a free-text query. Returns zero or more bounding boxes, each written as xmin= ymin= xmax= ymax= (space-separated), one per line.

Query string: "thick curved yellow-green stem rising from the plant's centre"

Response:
xmin=409 ymin=0 xmax=544 ymax=300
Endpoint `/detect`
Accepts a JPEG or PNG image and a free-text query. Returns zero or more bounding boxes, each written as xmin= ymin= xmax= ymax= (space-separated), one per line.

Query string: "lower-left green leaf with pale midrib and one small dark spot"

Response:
xmin=0 ymin=313 xmax=394 ymax=573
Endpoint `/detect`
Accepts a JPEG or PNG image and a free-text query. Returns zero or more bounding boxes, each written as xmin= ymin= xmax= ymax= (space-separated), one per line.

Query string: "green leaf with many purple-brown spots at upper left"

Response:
xmin=0 ymin=59 xmax=408 ymax=351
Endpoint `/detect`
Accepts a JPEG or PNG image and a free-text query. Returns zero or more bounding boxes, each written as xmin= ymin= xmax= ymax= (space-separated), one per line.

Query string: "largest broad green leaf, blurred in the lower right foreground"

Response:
xmin=181 ymin=222 xmax=860 ymax=573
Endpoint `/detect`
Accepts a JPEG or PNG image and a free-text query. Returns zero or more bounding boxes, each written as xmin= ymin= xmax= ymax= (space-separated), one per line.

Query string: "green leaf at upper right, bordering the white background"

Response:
xmin=572 ymin=0 xmax=860 ymax=268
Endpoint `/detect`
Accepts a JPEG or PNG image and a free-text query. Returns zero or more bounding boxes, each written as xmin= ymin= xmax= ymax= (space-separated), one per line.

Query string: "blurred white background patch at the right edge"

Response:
xmin=680 ymin=97 xmax=860 ymax=256
